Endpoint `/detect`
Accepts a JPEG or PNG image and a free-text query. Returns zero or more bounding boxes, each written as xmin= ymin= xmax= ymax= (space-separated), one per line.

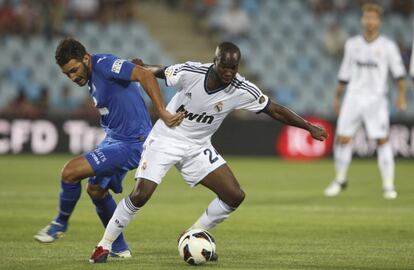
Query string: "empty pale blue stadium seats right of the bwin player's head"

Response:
xmin=234 ymin=0 xmax=414 ymax=117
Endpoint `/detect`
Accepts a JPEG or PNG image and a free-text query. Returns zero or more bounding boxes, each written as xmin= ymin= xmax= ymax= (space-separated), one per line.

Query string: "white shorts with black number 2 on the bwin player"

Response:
xmin=135 ymin=137 xmax=226 ymax=187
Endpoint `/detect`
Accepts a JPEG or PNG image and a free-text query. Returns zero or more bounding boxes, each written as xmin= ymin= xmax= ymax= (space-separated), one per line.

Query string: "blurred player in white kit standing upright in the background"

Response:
xmin=325 ymin=3 xmax=406 ymax=199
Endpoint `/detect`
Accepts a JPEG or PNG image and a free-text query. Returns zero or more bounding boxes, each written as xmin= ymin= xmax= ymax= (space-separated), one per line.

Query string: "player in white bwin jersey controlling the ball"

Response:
xmin=90 ymin=42 xmax=327 ymax=263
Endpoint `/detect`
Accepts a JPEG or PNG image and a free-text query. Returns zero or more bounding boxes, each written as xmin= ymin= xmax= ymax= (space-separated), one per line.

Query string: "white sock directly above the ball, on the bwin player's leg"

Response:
xmin=190 ymin=198 xmax=236 ymax=230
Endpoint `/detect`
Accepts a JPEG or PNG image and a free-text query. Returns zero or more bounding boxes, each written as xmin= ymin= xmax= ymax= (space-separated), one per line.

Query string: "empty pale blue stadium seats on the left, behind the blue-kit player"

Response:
xmin=0 ymin=23 xmax=173 ymax=108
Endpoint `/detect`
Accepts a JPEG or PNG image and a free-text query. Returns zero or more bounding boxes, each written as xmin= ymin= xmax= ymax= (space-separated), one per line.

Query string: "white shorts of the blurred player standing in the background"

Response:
xmin=336 ymin=96 xmax=390 ymax=139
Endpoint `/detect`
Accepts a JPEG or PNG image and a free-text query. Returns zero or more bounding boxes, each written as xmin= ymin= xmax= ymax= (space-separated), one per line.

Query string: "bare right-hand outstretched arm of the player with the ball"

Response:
xmin=264 ymin=102 xmax=328 ymax=141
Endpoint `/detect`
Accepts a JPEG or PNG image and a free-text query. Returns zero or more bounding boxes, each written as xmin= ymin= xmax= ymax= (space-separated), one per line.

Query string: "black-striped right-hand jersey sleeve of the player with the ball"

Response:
xmin=235 ymin=80 xmax=270 ymax=113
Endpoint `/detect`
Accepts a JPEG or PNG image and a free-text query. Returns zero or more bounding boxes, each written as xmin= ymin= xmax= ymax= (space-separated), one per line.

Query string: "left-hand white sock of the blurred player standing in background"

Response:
xmin=334 ymin=143 xmax=352 ymax=184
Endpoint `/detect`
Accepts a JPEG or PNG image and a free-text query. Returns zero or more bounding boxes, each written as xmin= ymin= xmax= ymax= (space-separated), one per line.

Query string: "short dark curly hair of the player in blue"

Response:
xmin=55 ymin=38 xmax=86 ymax=66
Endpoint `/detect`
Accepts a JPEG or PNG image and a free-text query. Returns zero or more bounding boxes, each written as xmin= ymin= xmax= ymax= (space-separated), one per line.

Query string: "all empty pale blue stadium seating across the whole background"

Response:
xmin=0 ymin=0 xmax=414 ymax=117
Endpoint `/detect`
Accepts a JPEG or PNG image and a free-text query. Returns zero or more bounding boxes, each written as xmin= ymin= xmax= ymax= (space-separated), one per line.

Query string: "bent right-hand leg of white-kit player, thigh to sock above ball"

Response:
xmin=190 ymin=164 xmax=245 ymax=230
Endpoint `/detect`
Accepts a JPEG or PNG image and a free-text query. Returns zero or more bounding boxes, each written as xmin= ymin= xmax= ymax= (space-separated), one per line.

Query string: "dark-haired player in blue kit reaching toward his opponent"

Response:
xmin=34 ymin=38 xmax=183 ymax=258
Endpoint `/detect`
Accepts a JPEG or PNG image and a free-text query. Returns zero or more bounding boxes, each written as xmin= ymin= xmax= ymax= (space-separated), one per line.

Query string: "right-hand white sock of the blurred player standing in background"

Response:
xmin=377 ymin=142 xmax=395 ymax=190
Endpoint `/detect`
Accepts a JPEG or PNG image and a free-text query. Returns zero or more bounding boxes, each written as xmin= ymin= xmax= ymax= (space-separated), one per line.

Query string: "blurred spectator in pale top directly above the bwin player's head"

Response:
xmin=219 ymin=1 xmax=250 ymax=43
